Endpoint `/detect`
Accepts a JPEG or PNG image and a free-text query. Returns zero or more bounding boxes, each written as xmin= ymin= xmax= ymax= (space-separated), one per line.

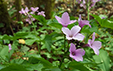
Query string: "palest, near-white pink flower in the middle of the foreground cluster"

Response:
xmin=62 ymin=26 xmax=84 ymax=41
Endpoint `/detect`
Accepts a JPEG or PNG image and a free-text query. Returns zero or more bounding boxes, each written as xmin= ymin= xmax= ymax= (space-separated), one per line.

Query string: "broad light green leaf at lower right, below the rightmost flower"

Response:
xmin=93 ymin=50 xmax=111 ymax=71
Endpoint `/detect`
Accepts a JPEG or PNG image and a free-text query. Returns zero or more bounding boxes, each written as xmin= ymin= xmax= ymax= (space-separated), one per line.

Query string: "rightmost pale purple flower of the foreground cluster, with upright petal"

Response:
xmin=88 ymin=32 xmax=102 ymax=55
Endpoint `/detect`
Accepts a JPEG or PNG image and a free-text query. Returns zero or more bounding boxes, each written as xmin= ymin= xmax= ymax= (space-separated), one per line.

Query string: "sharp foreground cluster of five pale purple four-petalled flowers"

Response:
xmin=55 ymin=12 xmax=101 ymax=61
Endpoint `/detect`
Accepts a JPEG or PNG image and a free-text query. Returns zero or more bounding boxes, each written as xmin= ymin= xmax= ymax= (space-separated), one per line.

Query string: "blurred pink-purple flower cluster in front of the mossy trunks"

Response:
xmin=19 ymin=7 xmax=45 ymax=24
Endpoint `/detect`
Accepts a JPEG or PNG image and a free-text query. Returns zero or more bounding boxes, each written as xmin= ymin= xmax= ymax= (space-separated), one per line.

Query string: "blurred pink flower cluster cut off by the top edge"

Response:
xmin=76 ymin=0 xmax=100 ymax=9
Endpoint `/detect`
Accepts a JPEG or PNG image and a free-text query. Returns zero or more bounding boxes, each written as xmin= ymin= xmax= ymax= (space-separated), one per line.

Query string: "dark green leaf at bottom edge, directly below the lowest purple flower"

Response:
xmin=69 ymin=61 xmax=89 ymax=71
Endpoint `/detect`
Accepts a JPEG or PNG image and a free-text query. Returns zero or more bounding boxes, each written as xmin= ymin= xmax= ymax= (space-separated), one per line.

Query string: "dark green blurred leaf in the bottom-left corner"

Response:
xmin=0 ymin=64 xmax=27 ymax=71
